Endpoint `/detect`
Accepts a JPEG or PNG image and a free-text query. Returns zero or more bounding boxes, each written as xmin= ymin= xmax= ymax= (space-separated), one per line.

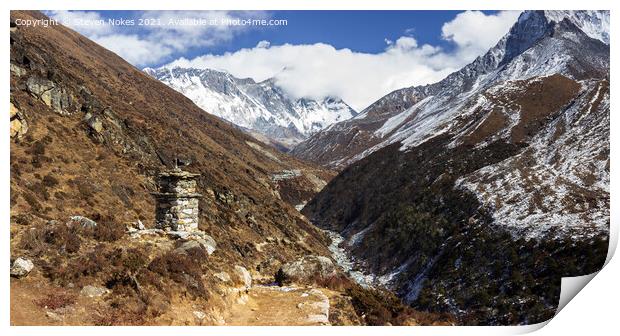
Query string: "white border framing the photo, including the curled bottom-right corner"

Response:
xmin=0 ymin=0 xmax=620 ymax=336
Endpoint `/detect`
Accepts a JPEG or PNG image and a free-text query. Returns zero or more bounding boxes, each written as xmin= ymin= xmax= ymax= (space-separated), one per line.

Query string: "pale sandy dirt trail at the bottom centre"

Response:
xmin=226 ymin=286 xmax=329 ymax=326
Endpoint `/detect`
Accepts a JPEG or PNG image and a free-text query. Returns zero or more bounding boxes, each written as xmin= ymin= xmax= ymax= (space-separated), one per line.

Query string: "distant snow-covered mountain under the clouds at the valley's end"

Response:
xmin=144 ymin=66 xmax=357 ymax=145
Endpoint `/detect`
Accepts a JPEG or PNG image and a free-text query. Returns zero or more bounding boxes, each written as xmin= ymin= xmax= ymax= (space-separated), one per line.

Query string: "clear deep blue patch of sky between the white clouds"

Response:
xmin=165 ymin=11 xmax=470 ymax=62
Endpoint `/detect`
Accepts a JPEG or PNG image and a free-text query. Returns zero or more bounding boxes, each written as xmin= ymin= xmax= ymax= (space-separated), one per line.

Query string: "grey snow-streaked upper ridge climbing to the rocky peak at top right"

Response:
xmin=291 ymin=11 xmax=609 ymax=169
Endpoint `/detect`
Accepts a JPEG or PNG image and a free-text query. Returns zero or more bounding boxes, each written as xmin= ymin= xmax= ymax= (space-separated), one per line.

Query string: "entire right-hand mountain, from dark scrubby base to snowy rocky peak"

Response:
xmin=302 ymin=11 xmax=609 ymax=324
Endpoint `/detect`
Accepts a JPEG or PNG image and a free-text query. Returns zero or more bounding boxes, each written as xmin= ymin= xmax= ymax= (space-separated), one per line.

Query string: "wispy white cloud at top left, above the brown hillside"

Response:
xmin=47 ymin=11 xmax=268 ymax=66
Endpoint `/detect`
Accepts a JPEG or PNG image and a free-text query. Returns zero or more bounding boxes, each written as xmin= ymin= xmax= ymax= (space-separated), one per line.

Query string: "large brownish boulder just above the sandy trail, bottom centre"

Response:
xmin=276 ymin=255 xmax=337 ymax=284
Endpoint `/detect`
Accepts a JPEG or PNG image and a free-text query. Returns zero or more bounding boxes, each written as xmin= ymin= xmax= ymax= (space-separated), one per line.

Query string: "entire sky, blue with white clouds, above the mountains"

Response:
xmin=47 ymin=11 xmax=519 ymax=110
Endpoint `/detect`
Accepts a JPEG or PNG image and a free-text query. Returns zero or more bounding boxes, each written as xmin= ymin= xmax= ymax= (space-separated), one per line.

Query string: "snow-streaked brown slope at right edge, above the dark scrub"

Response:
xmin=456 ymin=81 xmax=610 ymax=240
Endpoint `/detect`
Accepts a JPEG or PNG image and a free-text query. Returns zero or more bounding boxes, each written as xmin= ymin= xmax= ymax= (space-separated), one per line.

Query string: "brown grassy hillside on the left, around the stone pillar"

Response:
xmin=10 ymin=11 xmax=449 ymax=325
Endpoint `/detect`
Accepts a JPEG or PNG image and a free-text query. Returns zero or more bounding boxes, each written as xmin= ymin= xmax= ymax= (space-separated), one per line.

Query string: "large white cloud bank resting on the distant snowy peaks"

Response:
xmin=167 ymin=12 xmax=518 ymax=111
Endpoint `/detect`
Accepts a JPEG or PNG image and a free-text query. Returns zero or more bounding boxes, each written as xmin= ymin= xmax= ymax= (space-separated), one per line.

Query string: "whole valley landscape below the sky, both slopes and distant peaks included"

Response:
xmin=10 ymin=11 xmax=610 ymax=326
